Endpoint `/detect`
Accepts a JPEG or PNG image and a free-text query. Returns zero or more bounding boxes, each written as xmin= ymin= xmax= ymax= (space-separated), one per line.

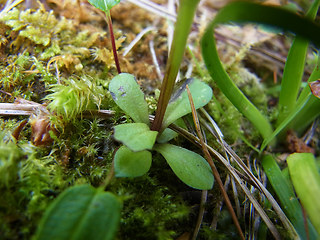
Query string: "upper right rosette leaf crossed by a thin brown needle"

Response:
xmin=162 ymin=78 xmax=212 ymax=129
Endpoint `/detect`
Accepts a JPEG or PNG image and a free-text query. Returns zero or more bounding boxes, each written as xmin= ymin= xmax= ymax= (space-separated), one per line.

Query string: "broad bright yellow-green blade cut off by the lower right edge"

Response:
xmin=287 ymin=153 xmax=320 ymax=234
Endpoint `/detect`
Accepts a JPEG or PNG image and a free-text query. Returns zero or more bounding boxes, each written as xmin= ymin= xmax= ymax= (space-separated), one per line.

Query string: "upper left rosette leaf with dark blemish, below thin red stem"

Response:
xmin=109 ymin=73 xmax=149 ymax=125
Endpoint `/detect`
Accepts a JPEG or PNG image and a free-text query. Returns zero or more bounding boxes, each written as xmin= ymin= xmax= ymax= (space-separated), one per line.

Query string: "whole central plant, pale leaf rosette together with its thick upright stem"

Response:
xmin=109 ymin=0 xmax=213 ymax=189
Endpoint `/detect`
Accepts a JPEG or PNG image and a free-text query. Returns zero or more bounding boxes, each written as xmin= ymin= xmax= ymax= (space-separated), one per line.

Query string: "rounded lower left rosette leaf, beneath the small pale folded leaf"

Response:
xmin=114 ymin=146 xmax=152 ymax=177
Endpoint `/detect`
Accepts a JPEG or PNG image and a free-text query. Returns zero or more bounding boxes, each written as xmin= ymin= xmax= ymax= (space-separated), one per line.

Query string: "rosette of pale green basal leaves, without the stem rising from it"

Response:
xmin=109 ymin=73 xmax=213 ymax=189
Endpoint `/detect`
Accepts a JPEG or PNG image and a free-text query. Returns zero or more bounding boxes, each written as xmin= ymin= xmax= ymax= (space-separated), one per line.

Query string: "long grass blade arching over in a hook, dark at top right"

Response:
xmin=201 ymin=1 xmax=320 ymax=139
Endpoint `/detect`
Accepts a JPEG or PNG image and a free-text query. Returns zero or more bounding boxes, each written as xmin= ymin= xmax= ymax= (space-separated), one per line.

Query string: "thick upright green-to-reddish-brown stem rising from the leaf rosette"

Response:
xmin=151 ymin=0 xmax=200 ymax=131
